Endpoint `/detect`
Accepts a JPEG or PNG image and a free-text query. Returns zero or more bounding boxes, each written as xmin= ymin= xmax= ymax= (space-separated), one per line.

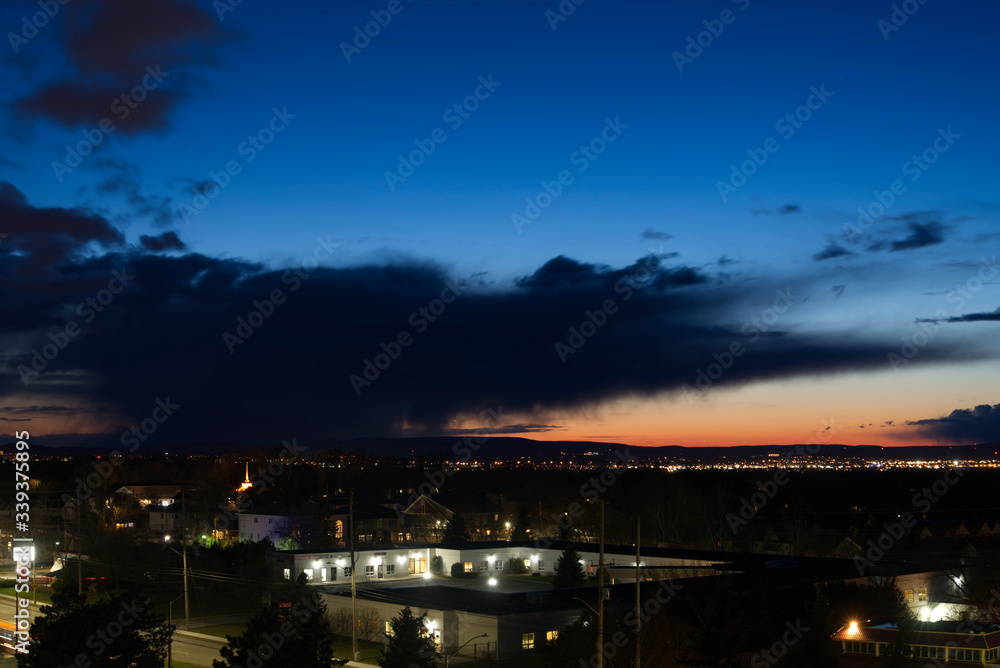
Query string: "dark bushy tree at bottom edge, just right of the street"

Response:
xmin=215 ymin=593 xmax=347 ymax=668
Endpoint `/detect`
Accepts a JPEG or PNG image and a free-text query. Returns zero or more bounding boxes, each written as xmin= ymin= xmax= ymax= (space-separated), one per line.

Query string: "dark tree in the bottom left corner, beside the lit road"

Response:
xmin=17 ymin=591 xmax=174 ymax=668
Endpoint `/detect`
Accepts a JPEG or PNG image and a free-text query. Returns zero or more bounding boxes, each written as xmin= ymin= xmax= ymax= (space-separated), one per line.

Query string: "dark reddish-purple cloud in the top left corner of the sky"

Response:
xmin=17 ymin=0 xmax=226 ymax=135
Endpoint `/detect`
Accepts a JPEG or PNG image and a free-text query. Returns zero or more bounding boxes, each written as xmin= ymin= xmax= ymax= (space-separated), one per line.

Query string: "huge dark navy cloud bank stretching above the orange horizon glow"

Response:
xmin=0 ymin=186 xmax=988 ymax=447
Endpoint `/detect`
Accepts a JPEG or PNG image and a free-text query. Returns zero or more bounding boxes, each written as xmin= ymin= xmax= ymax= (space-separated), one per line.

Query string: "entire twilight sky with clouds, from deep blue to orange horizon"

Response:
xmin=0 ymin=0 xmax=1000 ymax=449
